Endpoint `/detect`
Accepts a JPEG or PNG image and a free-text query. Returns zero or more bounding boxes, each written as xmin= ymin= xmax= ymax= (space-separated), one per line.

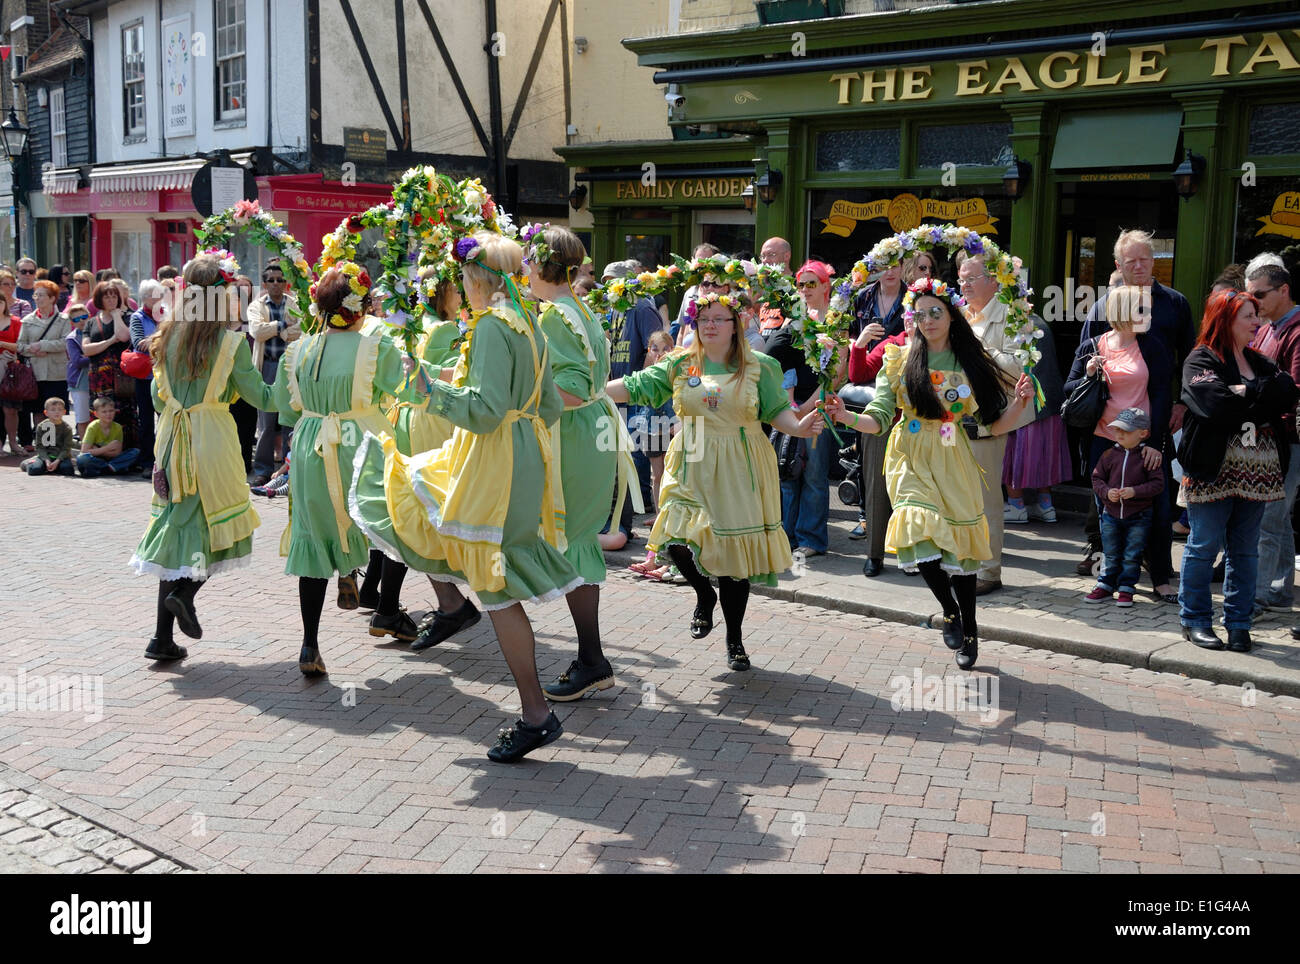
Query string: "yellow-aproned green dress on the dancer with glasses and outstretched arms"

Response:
xmin=623 ymin=343 xmax=793 ymax=586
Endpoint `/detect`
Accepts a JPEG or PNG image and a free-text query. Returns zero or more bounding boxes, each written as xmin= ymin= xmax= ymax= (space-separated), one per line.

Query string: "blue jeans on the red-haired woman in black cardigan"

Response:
xmin=1178 ymin=499 xmax=1268 ymax=630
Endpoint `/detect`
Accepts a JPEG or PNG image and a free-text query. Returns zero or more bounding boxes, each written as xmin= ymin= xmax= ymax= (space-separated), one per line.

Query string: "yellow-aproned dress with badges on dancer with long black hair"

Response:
xmin=866 ymin=344 xmax=998 ymax=573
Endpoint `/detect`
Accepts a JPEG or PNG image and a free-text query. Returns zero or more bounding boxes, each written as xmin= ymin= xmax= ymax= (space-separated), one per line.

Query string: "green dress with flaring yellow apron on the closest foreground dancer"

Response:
xmin=348 ymin=307 xmax=582 ymax=611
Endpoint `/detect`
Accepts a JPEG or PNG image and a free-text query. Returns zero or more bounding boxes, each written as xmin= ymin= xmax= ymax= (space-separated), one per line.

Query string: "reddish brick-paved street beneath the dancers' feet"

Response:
xmin=0 ymin=470 xmax=1300 ymax=873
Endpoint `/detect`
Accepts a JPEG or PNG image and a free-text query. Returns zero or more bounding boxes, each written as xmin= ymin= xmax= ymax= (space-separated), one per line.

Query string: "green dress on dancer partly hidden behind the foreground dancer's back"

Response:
xmin=540 ymin=298 xmax=618 ymax=586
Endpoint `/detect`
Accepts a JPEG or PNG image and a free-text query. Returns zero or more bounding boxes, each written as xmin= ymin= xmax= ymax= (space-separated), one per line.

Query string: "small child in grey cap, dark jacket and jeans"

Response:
xmin=1084 ymin=408 xmax=1165 ymax=607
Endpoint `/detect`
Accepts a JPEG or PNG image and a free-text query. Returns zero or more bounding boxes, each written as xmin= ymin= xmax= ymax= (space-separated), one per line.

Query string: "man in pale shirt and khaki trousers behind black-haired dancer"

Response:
xmin=957 ymin=252 xmax=1035 ymax=595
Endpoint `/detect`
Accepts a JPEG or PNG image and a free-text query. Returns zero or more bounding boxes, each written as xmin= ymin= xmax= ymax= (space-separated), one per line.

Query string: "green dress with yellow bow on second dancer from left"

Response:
xmin=276 ymin=331 xmax=437 ymax=579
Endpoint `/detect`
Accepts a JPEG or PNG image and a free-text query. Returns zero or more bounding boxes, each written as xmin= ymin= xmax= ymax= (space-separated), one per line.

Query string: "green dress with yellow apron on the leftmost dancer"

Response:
xmin=130 ymin=331 xmax=274 ymax=582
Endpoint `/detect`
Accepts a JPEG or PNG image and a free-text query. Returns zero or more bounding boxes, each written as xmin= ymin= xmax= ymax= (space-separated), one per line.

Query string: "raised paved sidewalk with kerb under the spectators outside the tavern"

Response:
xmin=611 ymin=492 xmax=1300 ymax=696
